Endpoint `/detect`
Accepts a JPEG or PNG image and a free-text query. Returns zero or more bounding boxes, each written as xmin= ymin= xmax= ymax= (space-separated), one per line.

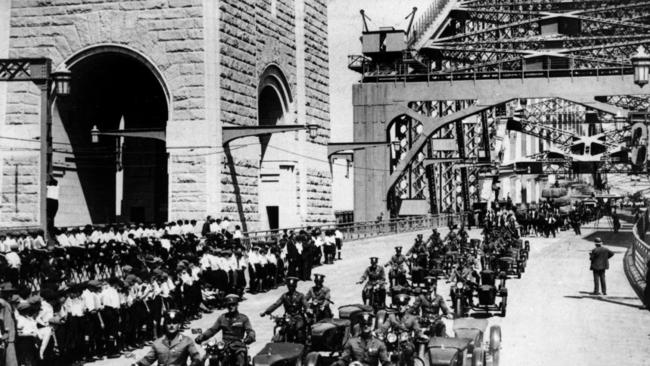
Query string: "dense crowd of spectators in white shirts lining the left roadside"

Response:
xmin=0 ymin=217 xmax=343 ymax=366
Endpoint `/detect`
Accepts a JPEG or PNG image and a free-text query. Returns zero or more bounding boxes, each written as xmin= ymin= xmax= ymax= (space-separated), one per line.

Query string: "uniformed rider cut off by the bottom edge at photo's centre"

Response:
xmin=331 ymin=312 xmax=392 ymax=366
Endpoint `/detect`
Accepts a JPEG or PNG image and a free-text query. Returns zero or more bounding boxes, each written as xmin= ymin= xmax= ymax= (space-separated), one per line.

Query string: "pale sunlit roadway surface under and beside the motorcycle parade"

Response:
xmin=94 ymin=222 xmax=650 ymax=366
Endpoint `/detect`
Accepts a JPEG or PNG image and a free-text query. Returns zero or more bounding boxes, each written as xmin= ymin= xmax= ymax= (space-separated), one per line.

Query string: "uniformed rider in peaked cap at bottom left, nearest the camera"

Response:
xmin=133 ymin=310 xmax=203 ymax=366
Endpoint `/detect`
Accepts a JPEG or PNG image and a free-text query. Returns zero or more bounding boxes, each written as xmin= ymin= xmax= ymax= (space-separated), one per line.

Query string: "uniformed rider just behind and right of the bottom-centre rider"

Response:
xmin=380 ymin=293 xmax=426 ymax=365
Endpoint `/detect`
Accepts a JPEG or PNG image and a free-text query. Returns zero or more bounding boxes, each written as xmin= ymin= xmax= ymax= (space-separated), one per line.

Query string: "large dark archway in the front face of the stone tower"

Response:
xmin=53 ymin=47 xmax=169 ymax=226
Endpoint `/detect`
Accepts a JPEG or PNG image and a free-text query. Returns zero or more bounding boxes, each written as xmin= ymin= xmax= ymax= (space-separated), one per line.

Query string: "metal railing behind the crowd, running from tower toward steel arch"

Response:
xmin=235 ymin=214 xmax=464 ymax=246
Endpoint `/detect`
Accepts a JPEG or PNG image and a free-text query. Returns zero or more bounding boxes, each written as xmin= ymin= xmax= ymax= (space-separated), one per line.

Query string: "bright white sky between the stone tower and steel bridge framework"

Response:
xmin=328 ymin=0 xmax=434 ymax=142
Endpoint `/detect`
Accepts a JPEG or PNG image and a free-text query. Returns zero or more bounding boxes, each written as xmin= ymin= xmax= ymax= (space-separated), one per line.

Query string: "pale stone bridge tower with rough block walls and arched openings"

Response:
xmin=0 ymin=0 xmax=333 ymax=230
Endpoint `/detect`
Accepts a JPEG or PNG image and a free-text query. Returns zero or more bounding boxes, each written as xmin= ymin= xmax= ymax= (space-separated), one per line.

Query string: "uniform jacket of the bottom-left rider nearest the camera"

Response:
xmin=137 ymin=334 xmax=202 ymax=366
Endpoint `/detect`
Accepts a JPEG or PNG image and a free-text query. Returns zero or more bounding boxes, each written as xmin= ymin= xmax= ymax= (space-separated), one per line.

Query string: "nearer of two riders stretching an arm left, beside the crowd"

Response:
xmin=194 ymin=294 xmax=255 ymax=366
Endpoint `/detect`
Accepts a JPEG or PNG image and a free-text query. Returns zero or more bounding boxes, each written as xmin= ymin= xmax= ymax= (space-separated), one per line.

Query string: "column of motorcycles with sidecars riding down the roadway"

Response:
xmin=196 ymin=239 xmax=530 ymax=366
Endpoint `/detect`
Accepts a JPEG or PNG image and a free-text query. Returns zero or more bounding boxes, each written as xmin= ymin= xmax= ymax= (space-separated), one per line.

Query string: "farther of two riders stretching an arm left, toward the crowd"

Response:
xmin=260 ymin=277 xmax=309 ymax=343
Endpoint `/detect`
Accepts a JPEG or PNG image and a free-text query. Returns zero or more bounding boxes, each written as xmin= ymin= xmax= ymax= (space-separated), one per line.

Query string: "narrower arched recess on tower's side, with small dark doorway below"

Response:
xmin=257 ymin=66 xmax=300 ymax=230
